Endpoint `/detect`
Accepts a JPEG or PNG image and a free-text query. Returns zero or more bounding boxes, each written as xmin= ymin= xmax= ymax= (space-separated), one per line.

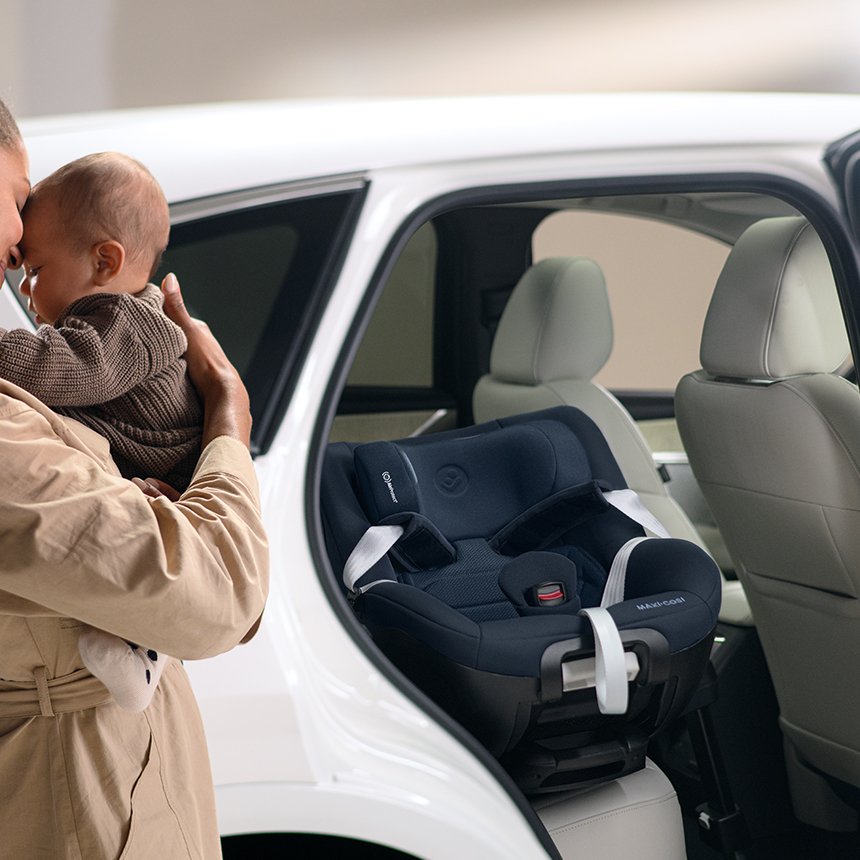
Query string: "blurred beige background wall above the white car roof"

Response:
xmin=5 ymin=0 xmax=860 ymax=117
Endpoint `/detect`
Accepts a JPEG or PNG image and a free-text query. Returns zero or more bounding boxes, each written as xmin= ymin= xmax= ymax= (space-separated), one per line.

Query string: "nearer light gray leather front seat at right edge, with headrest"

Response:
xmin=675 ymin=218 xmax=860 ymax=830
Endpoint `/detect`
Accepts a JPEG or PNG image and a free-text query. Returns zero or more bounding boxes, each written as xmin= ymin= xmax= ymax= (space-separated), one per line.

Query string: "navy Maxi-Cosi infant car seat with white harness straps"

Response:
xmin=321 ymin=406 xmax=720 ymax=792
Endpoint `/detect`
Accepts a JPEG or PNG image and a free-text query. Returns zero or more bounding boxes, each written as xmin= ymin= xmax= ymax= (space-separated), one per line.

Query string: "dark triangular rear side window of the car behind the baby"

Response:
xmin=156 ymin=190 xmax=360 ymax=450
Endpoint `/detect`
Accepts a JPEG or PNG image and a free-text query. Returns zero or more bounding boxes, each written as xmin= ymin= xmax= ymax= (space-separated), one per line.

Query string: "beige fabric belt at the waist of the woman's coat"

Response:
xmin=0 ymin=666 xmax=112 ymax=719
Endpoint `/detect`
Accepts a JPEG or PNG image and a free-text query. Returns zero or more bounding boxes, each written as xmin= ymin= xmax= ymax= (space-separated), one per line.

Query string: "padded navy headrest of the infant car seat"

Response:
xmin=354 ymin=421 xmax=592 ymax=540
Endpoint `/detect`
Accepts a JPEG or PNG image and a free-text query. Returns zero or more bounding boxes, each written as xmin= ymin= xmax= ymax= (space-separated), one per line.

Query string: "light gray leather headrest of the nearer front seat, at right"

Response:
xmin=700 ymin=217 xmax=849 ymax=379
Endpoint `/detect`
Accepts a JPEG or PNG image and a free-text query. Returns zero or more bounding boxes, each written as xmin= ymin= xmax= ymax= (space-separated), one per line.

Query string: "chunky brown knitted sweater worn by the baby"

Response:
xmin=0 ymin=284 xmax=203 ymax=491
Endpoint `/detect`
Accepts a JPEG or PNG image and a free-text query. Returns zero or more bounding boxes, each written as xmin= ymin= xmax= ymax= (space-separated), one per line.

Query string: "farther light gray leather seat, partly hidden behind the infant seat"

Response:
xmin=472 ymin=257 xmax=752 ymax=624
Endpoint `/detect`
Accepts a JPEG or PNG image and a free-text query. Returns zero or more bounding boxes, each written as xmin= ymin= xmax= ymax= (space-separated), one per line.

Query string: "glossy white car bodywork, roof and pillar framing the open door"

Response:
xmin=10 ymin=90 xmax=860 ymax=860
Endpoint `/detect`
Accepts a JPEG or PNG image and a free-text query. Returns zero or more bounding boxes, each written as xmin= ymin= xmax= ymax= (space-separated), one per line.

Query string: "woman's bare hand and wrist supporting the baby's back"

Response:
xmin=161 ymin=274 xmax=251 ymax=448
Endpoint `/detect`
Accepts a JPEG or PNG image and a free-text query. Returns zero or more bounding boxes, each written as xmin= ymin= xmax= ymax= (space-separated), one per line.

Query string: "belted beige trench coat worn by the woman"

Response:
xmin=0 ymin=380 xmax=268 ymax=860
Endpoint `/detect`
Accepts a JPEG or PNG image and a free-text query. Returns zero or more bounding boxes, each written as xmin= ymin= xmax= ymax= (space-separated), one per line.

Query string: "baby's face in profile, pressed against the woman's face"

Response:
xmin=20 ymin=198 xmax=93 ymax=325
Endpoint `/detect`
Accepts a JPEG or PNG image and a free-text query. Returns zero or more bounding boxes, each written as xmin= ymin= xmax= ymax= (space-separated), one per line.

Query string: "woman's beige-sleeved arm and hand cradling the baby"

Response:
xmin=0 ymin=278 xmax=268 ymax=659
